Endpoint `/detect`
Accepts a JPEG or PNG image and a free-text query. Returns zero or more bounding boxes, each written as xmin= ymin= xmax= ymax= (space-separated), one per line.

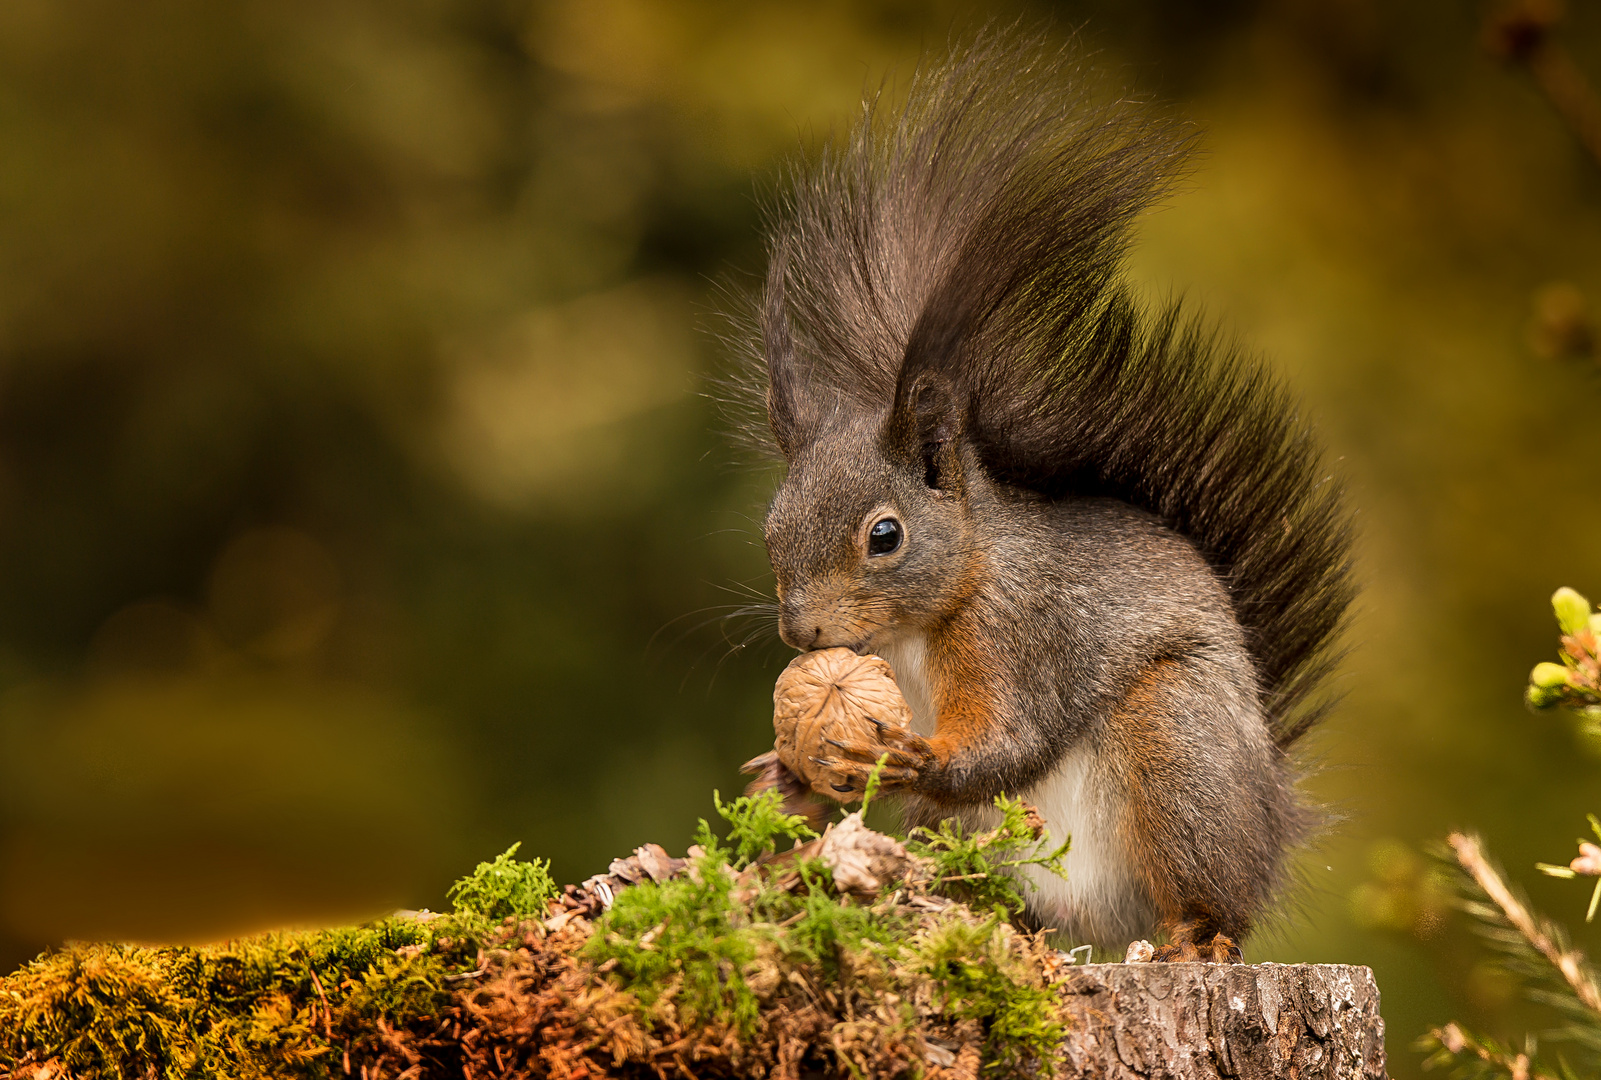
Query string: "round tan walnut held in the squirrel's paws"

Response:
xmin=773 ymin=648 xmax=911 ymax=802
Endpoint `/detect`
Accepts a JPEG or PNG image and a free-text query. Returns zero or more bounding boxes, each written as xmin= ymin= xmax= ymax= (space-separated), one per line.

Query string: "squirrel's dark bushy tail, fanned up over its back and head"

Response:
xmin=723 ymin=32 xmax=1353 ymax=746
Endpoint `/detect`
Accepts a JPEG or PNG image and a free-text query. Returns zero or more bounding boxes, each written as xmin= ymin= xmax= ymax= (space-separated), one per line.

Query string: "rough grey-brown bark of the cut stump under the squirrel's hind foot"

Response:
xmin=1058 ymin=963 xmax=1385 ymax=1080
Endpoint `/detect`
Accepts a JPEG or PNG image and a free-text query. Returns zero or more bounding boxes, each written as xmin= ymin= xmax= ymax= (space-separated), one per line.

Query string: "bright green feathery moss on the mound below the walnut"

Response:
xmin=583 ymin=792 xmax=1066 ymax=1074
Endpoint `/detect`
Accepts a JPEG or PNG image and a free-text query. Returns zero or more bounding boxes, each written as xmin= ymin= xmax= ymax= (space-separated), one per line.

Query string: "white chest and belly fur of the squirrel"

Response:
xmin=877 ymin=635 xmax=1153 ymax=950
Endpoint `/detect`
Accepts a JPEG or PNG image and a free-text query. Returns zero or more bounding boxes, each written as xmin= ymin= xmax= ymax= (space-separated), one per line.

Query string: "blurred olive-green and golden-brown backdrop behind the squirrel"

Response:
xmin=0 ymin=0 xmax=1601 ymax=1075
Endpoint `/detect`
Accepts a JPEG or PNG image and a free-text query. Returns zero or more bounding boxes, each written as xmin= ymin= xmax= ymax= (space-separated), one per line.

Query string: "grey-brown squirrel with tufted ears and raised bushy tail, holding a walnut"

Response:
xmin=730 ymin=32 xmax=1354 ymax=962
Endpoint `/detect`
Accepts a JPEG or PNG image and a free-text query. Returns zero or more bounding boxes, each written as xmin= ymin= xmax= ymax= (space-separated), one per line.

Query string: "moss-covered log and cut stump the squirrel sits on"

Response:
xmin=0 ymin=794 xmax=1382 ymax=1080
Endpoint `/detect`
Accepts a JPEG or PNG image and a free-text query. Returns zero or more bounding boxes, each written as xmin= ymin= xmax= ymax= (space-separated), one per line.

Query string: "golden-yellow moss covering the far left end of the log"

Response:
xmin=0 ymin=864 xmax=527 ymax=1080
